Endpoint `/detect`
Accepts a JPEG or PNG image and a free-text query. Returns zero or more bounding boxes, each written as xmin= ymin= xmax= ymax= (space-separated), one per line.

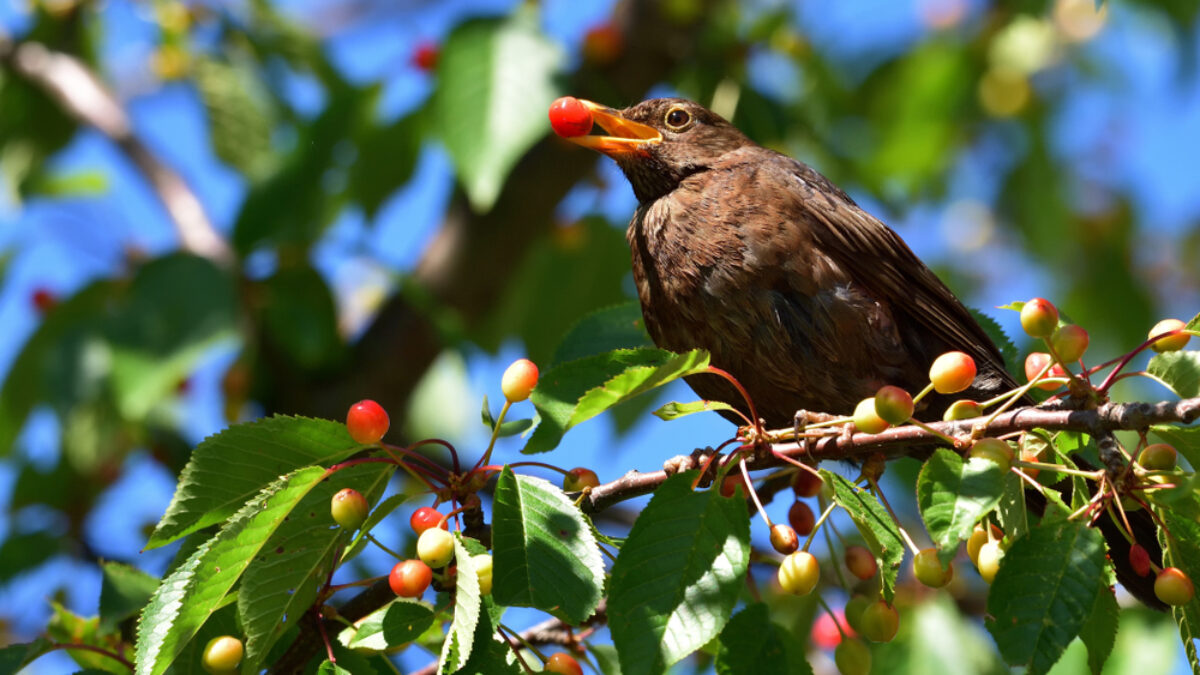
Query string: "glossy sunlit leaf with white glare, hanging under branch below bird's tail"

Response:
xmin=917 ymin=448 xmax=1008 ymax=566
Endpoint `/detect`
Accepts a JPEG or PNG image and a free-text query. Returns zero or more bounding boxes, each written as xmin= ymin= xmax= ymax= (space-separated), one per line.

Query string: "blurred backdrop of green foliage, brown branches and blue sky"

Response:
xmin=0 ymin=0 xmax=1200 ymax=671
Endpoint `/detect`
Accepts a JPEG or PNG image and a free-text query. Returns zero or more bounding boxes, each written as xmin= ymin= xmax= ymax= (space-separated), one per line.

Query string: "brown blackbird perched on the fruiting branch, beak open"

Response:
xmin=559 ymin=98 xmax=1162 ymax=607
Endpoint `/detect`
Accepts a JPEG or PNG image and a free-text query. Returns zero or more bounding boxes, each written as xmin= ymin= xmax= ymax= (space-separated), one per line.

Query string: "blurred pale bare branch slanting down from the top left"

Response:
xmin=0 ymin=36 xmax=233 ymax=263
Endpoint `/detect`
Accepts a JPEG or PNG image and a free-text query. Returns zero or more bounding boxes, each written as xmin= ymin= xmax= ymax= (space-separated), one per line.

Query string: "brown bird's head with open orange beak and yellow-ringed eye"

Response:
xmin=568 ymin=98 xmax=751 ymax=203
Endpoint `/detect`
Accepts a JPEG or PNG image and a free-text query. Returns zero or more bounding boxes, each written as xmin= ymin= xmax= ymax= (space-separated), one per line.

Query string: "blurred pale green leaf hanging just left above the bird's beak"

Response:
xmin=430 ymin=12 xmax=563 ymax=213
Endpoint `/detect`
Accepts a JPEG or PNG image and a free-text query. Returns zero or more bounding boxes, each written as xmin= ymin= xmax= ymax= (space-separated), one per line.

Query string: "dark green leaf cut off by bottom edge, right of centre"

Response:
xmin=716 ymin=603 xmax=812 ymax=675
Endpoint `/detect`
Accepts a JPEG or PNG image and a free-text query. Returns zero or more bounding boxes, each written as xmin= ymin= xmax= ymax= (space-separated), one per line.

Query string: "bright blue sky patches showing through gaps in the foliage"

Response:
xmin=0 ymin=0 xmax=1200 ymax=673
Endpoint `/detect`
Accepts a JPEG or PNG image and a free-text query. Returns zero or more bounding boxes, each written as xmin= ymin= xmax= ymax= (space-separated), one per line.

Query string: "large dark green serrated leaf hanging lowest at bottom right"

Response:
xmin=986 ymin=520 xmax=1105 ymax=674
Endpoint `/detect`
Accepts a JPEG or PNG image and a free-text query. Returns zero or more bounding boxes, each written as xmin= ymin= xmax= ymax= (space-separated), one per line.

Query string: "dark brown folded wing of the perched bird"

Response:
xmin=780 ymin=155 xmax=1013 ymax=386
